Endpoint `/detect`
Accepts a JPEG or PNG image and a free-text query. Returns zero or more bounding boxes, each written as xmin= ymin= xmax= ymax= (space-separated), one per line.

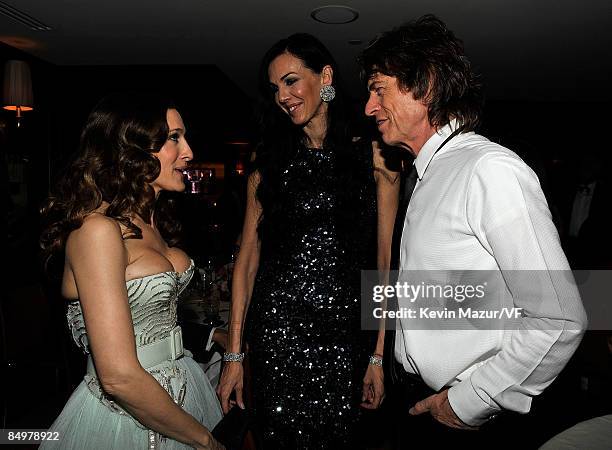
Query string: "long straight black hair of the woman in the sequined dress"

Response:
xmin=252 ymin=33 xmax=354 ymax=237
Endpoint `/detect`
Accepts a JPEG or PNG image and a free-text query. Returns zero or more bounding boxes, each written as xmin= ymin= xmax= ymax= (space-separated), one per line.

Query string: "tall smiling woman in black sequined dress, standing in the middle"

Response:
xmin=218 ymin=34 xmax=398 ymax=449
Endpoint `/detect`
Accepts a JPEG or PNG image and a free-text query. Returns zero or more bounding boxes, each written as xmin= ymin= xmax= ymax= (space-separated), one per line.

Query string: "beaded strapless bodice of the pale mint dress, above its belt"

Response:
xmin=66 ymin=261 xmax=195 ymax=353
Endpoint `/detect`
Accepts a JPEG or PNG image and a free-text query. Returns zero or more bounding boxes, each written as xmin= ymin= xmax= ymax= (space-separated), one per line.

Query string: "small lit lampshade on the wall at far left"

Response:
xmin=3 ymin=60 xmax=34 ymax=118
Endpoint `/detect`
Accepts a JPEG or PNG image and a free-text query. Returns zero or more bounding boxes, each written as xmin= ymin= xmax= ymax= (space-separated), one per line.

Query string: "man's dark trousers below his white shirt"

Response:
xmin=386 ymin=368 xmax=538 ymax=450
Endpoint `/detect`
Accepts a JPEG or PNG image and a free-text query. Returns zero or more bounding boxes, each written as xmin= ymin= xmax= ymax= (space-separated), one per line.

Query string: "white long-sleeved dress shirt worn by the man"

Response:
xmin=395 ymin=123 xmax=586 ymax=425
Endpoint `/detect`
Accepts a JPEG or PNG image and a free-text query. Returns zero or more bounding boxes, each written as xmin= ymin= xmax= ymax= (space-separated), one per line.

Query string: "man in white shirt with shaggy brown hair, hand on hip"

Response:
xmin=361 ymin=15 xmax=586 ymax=446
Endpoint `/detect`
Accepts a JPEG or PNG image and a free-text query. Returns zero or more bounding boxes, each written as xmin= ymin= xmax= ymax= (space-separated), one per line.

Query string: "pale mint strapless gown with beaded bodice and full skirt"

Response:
xmin=40 ymin=261 xmax=222 ymax=450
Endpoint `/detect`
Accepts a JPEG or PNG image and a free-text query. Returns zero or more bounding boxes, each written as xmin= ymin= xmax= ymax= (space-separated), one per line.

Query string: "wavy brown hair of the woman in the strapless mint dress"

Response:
xmin=40 ymin=93 xmax=180 ymax=270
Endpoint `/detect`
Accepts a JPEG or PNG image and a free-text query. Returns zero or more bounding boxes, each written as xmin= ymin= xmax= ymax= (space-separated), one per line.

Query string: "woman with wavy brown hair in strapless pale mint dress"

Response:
xmin=41 ymin=94 xmax=222 ymax=450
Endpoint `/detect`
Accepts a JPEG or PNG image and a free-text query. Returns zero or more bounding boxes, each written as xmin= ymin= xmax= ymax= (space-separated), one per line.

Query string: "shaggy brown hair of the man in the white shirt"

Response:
xmin=359 ymin=14 xmax=483 ymax=131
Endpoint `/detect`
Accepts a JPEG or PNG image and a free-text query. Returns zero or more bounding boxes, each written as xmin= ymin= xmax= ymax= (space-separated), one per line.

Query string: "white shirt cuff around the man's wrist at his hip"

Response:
xmin=448 ymin=378 xmax=501 ymax=426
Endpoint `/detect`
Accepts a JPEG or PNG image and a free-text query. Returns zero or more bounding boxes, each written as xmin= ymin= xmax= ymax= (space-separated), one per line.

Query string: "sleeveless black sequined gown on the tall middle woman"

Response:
xmin=246 ymin=142 xmax=376 ymax=450
